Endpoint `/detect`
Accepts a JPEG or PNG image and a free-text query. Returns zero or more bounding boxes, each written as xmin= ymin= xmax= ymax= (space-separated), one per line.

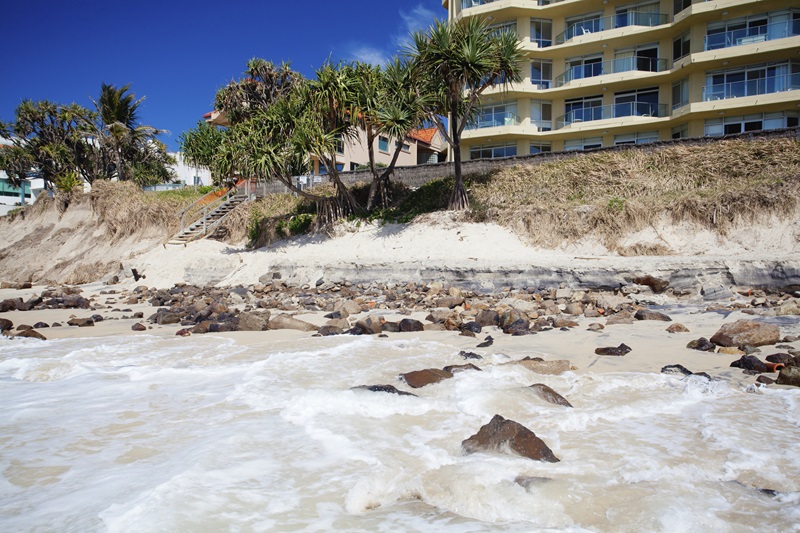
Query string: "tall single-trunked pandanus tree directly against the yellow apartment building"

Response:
xmin=408 ymin=17 xmax=523 ymax=210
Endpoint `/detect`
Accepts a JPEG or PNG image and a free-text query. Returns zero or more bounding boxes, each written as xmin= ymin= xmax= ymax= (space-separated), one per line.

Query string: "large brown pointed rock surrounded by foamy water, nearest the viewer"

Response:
xmin=461 ymin=415 xmax=559 ymax=463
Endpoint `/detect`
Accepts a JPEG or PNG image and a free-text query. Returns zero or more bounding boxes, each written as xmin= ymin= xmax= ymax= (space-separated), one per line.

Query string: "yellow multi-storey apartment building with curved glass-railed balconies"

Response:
xmin=442 ymin=0 xmax=800 ymax=159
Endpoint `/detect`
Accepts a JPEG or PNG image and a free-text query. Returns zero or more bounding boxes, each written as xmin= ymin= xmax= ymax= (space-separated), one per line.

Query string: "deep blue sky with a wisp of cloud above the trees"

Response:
xmin=0 ymin=0 xmax=440 ymax=150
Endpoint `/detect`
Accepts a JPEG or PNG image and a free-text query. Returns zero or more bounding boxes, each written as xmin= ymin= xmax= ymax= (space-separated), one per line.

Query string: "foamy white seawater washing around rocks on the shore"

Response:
xmin=0 ymin=330 xmax=800 ymax=532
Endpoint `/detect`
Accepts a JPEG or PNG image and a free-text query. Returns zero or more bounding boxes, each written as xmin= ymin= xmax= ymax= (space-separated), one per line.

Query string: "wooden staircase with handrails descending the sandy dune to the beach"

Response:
xmin=167 ymin=180 xmax=259 ymax=246
